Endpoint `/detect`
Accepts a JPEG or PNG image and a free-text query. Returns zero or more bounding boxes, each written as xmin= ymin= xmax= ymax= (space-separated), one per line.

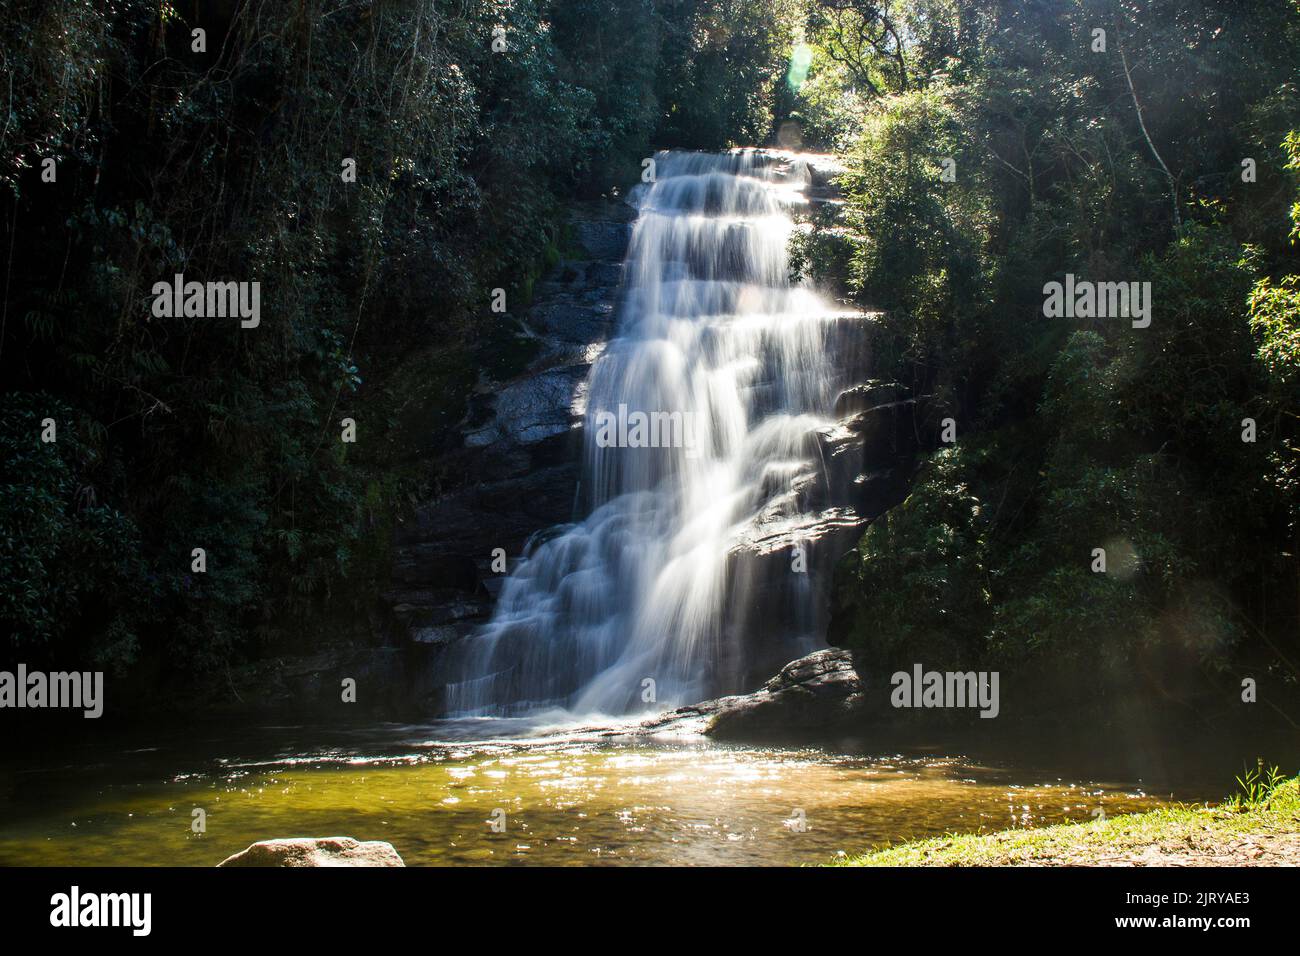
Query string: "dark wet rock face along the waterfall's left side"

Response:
xmin=385 ymin=202 xmax=636 ymax=713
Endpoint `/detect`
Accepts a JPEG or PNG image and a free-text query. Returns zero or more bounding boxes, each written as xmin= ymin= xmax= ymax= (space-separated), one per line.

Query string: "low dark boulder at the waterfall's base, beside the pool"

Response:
xmin=640 ymin=648 xmax=867 ymax=743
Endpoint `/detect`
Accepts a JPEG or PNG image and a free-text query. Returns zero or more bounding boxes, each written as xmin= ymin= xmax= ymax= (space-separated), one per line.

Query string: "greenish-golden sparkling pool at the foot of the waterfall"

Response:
xmin=0 ymin=721 xmax=1222 ymax=866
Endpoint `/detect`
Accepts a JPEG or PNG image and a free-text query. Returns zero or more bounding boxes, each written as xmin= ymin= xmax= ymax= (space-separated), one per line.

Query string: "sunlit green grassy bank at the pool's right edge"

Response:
xmin=837 ymin=777 xmax=1300 ymax=866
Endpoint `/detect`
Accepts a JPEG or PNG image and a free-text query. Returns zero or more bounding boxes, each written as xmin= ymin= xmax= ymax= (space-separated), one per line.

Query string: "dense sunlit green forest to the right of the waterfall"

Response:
xmin=805 ymin=0 xmax=1300 ymax=711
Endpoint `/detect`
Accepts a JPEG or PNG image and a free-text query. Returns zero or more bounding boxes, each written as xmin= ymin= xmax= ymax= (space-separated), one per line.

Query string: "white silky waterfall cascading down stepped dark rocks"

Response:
xmin=447 ymin=151 xmax=863 ymax=715
